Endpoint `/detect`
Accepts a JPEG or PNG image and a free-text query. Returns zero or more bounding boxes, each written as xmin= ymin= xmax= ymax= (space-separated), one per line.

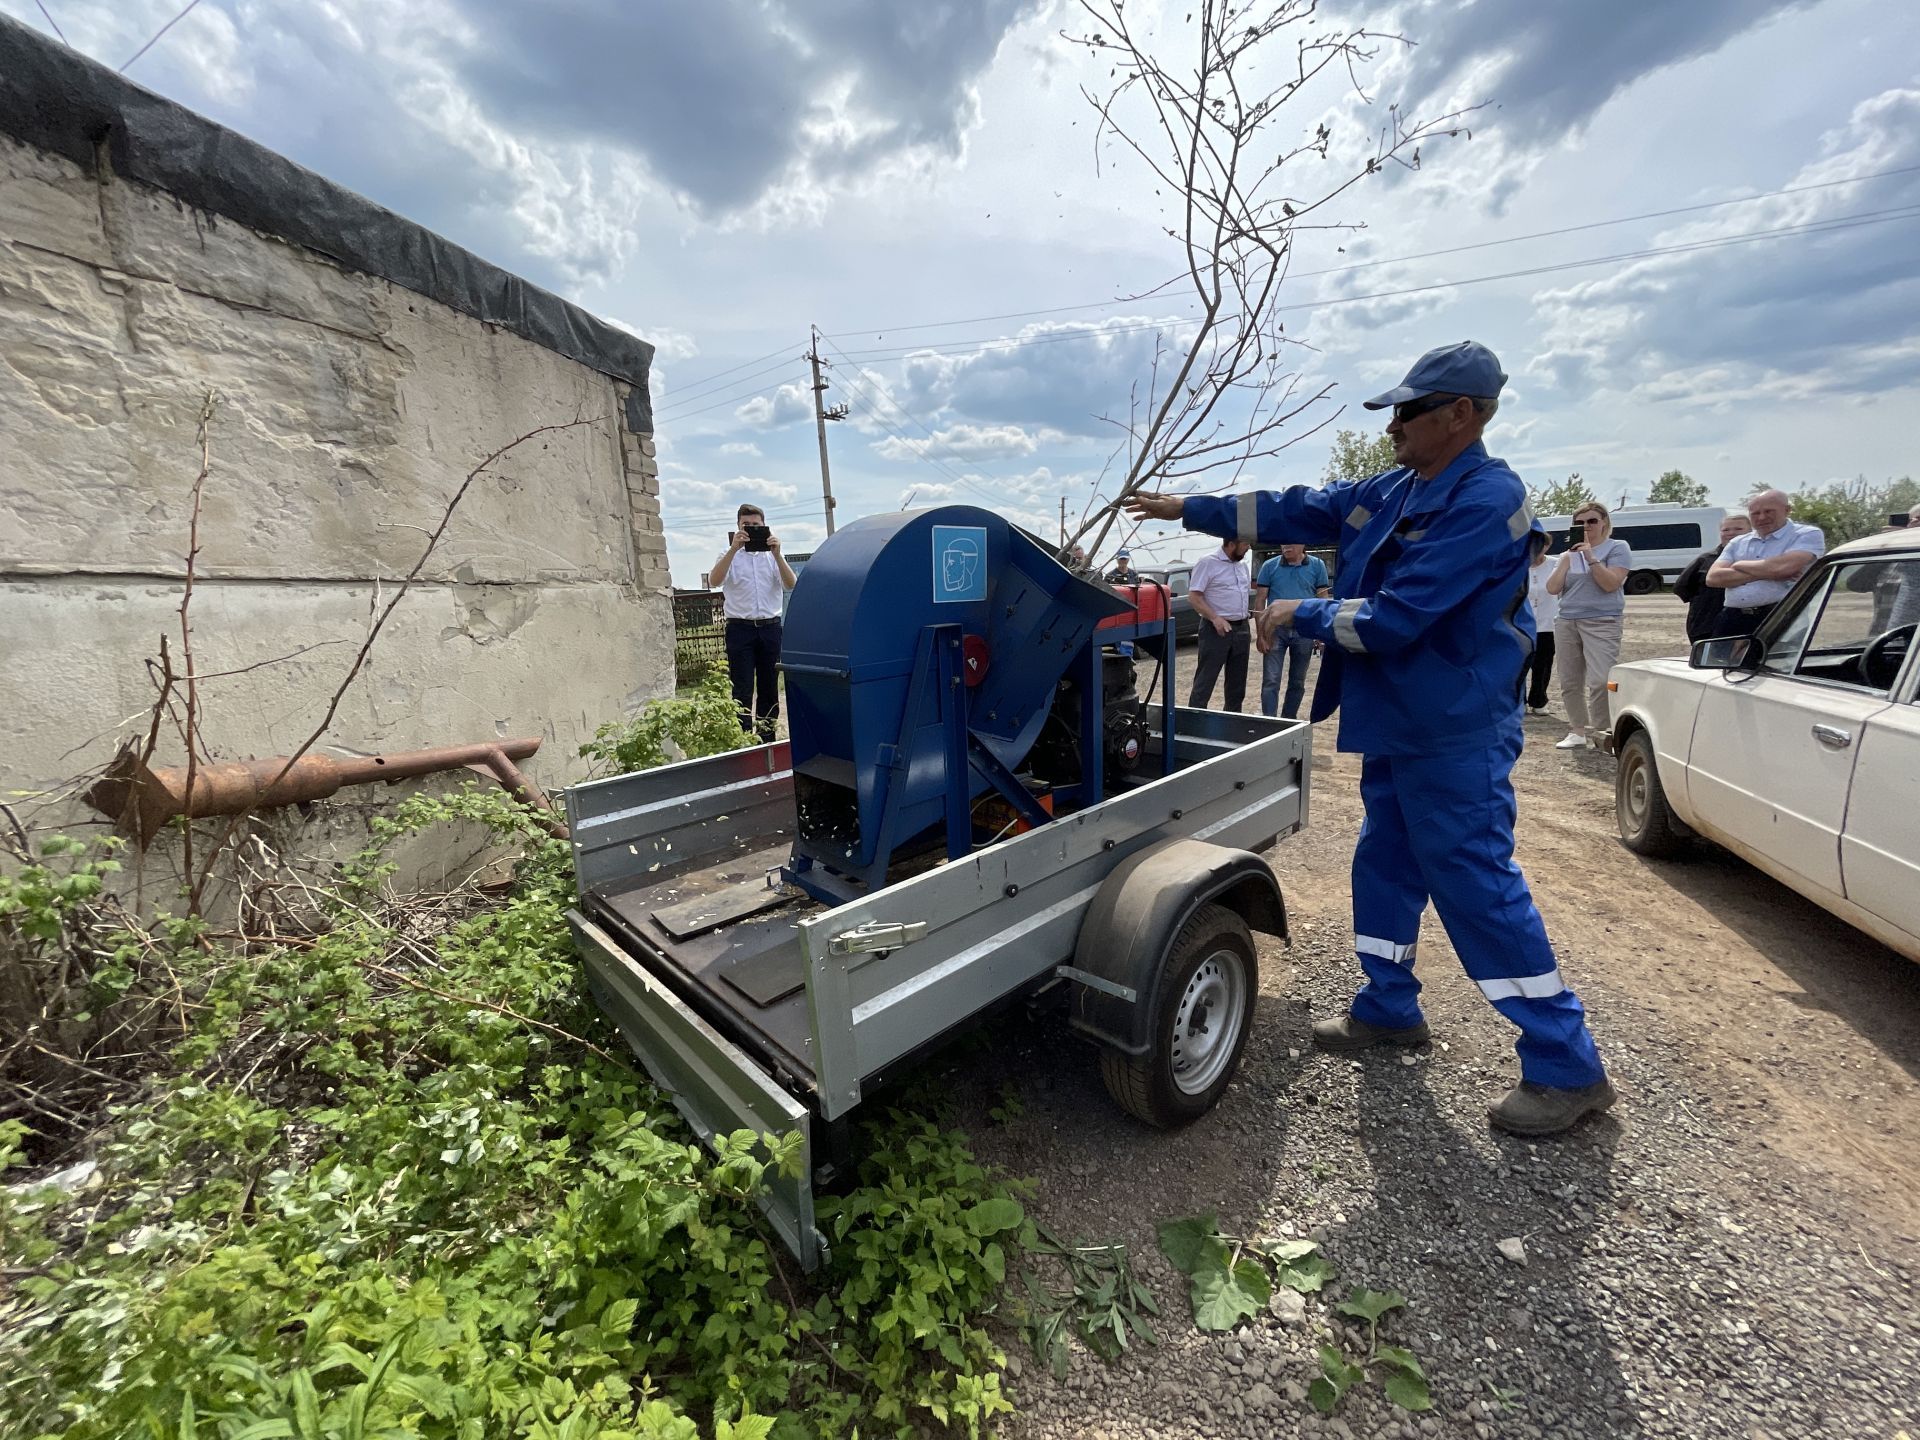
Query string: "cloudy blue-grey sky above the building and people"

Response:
xmin=15 ymin=0 xmax=1920 ymax=584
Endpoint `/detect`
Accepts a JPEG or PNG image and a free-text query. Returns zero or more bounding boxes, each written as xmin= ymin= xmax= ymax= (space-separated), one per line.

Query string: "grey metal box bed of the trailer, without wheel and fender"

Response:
xmin=566 ymin=708 xmax=1311 ymax=1265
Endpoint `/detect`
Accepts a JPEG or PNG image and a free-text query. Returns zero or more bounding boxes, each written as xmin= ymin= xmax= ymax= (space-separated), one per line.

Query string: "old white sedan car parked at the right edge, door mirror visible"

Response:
xmin=1607 ymin=530 xmax=1920 ymax=960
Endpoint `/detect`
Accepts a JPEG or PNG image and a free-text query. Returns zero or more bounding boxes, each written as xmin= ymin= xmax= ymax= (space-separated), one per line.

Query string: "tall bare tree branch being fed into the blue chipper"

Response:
xmin=1064 ymin=0 xmax=1461 ymax=555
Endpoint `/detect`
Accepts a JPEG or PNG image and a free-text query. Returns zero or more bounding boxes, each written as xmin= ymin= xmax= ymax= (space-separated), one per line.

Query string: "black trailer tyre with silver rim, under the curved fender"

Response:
xmin=1100 ymin=904 xmax=1260 ymax=1129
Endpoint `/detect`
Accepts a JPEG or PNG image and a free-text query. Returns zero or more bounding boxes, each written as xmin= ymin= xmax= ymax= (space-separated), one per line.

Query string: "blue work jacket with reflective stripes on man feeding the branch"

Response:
xmin=1183 ymin=442 xmax=1540 ymax=755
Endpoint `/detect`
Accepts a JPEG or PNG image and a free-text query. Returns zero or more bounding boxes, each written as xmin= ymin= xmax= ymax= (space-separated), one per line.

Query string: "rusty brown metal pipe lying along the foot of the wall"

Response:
xmin=86 ymin=735 xmax=547 ymax=847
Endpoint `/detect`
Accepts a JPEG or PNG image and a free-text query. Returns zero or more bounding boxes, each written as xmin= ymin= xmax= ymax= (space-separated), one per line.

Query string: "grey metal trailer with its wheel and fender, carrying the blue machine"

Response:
xmin=566 ymin=707 xmax=1311 ymax=1269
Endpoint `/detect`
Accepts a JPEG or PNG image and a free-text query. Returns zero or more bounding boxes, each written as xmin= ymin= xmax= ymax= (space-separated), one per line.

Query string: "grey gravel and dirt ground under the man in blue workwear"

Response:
xmin=921 ymin=595 xmax=1920 ymax=1440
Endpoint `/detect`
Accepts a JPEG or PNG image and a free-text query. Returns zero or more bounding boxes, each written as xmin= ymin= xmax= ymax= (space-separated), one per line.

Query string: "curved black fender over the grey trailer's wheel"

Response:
xmin=1066 ymin=839 xmax=1288 ymax=1056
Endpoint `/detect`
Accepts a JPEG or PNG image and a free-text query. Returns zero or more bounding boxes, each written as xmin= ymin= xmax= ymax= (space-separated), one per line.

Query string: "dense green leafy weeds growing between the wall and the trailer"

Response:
xmin=0 ymin=789 xmax=1025 ymax=1440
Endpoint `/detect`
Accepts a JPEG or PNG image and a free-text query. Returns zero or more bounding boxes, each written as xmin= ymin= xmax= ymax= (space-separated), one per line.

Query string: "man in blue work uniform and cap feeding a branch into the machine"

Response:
xmin=1127 ymin=340 xmax=1615 ymax=1135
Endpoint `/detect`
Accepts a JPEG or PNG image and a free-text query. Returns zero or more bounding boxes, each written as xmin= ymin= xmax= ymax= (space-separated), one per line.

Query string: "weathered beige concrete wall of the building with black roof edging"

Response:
xmin=0 ymin=136 xmax=674 ymax=821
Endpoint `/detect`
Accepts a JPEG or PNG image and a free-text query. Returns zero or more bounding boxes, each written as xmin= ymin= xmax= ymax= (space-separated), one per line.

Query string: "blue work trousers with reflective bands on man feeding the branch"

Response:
xmin=1354 ymin=724 xmax=1605 ymax=1089
